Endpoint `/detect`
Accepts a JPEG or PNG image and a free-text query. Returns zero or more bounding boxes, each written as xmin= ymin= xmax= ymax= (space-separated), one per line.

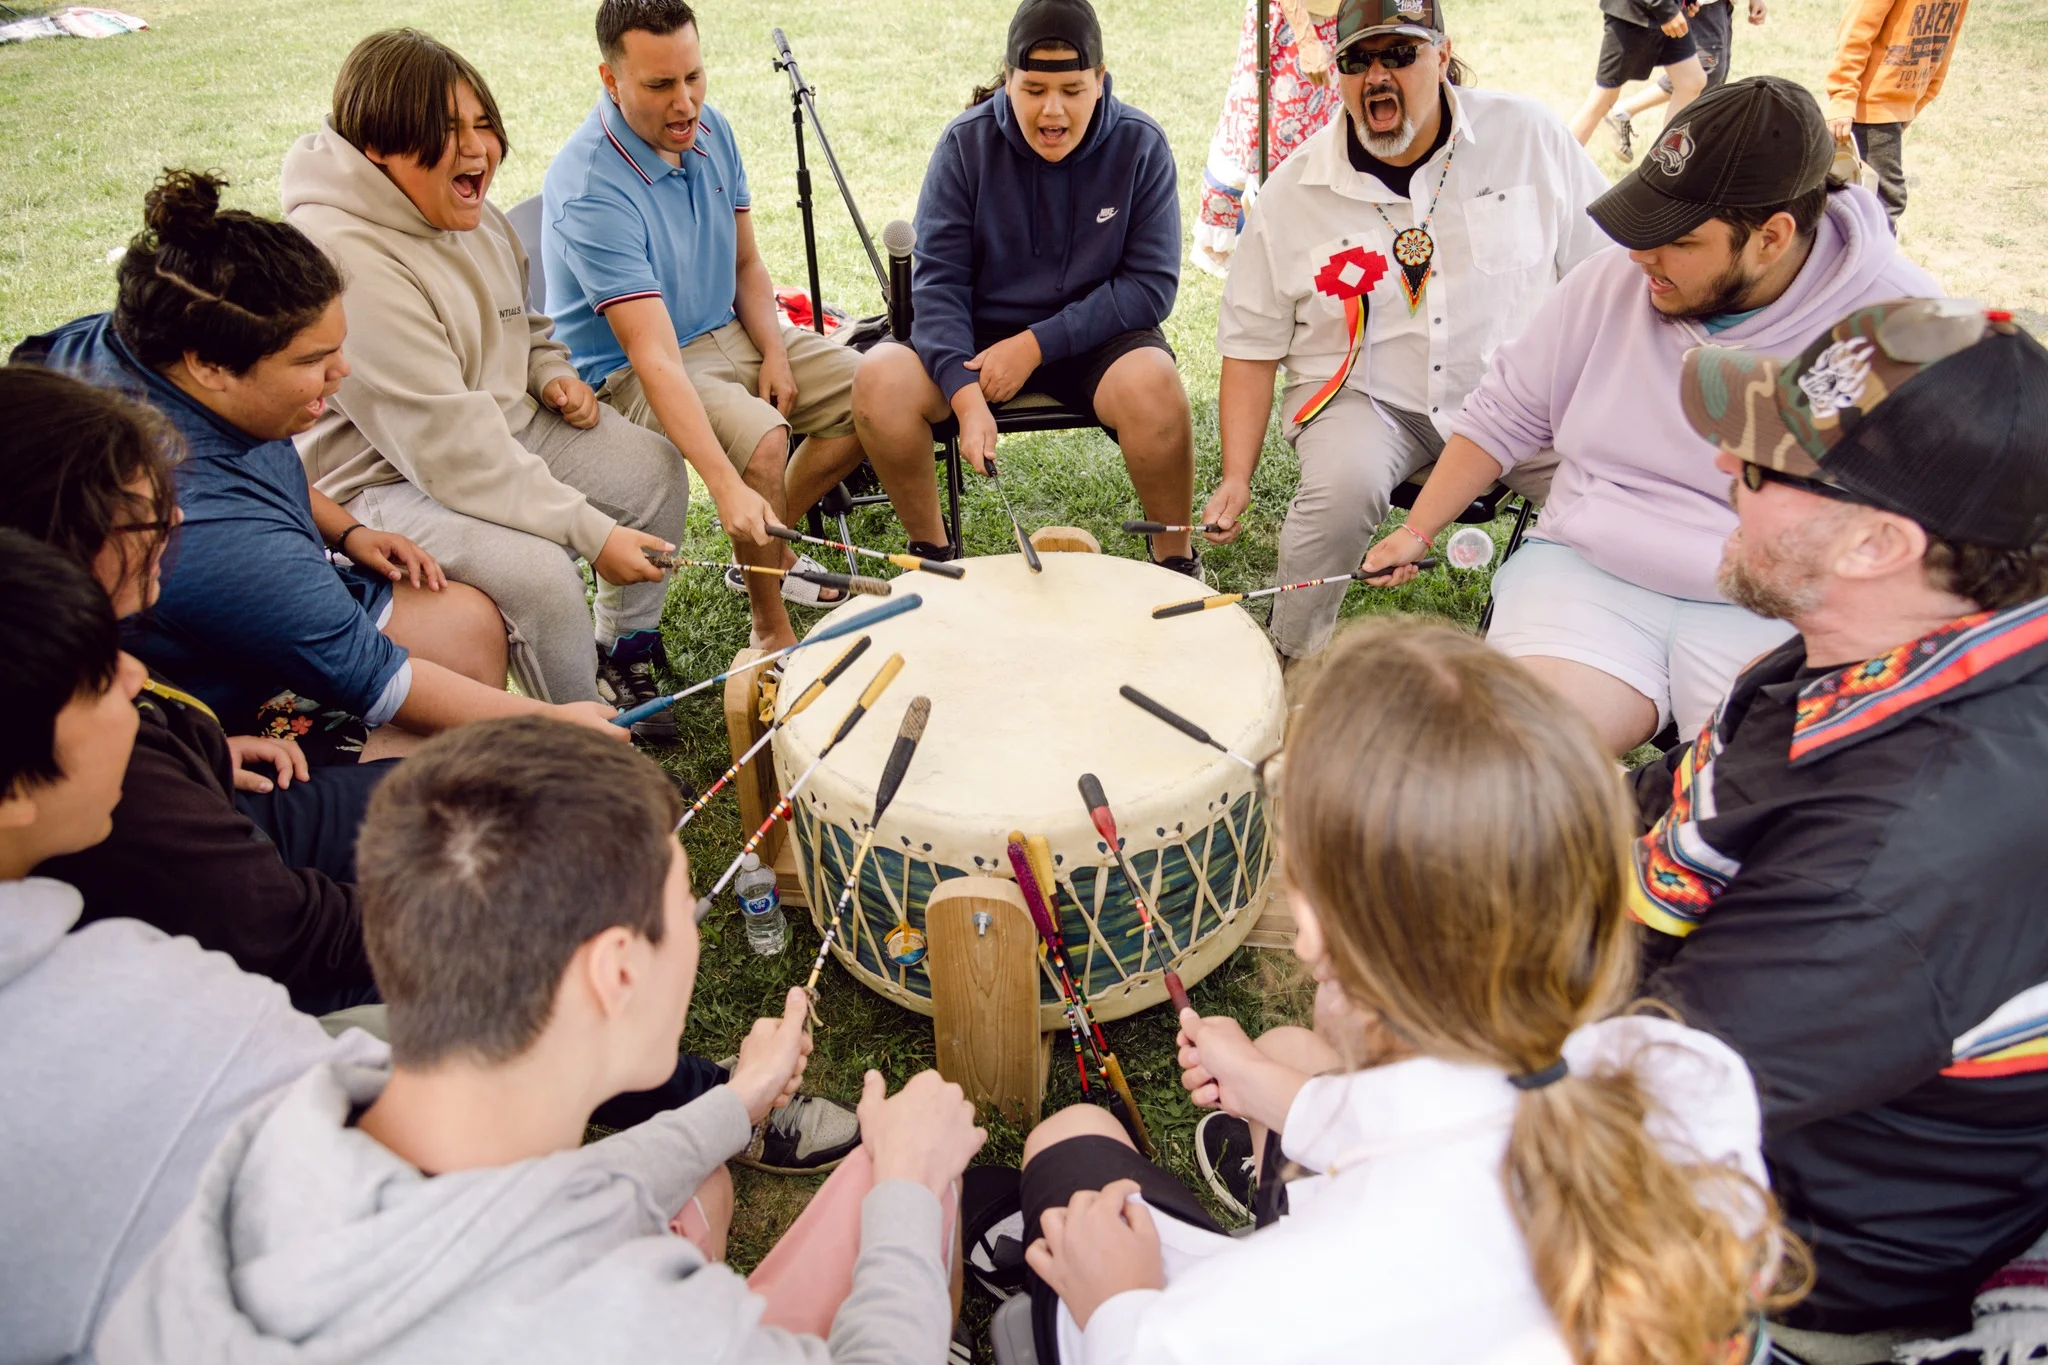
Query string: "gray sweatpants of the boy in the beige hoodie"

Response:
xmin=346 ymin=403 xmax=690 ymax=702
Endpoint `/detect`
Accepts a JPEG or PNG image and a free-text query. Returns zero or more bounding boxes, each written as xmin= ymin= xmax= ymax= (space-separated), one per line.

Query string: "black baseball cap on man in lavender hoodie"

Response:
xmin=1585 ymin=76 xmax=1835 ymax=252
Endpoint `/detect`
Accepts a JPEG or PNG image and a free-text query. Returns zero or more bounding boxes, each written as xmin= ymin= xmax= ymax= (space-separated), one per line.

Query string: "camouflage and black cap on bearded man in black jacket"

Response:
xmin=1679 ymin=299 xmax=2048 ymax=548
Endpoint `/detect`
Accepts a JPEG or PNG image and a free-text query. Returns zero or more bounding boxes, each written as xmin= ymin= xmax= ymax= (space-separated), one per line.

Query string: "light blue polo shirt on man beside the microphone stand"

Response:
xmin=541 ymin=94 xmax=754 ymax=387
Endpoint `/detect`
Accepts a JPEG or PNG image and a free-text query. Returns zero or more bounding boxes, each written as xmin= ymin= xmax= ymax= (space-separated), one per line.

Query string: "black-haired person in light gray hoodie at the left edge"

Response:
xmin=0 ymin=530 xmax=385 ymax=1365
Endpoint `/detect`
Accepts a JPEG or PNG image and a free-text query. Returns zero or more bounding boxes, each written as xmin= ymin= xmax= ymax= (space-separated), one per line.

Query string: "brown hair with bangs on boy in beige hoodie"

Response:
xmin=332 ymin=29 xmax=512 ymax=166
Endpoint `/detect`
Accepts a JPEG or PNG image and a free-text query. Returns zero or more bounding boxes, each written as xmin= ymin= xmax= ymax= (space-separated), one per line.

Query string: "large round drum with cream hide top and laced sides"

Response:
xmin=774 ymin=555 xmax=1286 ymax=1029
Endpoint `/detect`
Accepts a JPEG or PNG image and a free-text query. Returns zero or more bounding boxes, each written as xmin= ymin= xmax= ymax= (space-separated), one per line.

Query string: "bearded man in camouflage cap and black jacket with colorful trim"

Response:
xmin=1630 ymin=299 xmax=2048 ymax=1365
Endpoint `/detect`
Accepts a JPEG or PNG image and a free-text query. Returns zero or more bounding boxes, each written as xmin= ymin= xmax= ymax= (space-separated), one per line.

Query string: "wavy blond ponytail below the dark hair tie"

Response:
xmin=1501 ymin=1068 xmax=1810 ymax=1365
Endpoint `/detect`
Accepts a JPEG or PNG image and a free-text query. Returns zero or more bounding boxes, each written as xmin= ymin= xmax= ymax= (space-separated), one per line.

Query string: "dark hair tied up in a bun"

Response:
xmin=115 ymin=170 xmax=342 ymax=375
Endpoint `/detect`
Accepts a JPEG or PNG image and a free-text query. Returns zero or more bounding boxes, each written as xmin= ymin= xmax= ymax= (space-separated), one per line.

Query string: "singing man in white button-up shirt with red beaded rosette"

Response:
xmin=1202 ymin=0 xmax=1610 ymax=659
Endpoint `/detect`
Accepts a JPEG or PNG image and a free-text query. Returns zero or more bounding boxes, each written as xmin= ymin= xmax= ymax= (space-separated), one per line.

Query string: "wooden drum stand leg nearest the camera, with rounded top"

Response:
xmin=924 ymin=876 xmax=1044 ymax=1130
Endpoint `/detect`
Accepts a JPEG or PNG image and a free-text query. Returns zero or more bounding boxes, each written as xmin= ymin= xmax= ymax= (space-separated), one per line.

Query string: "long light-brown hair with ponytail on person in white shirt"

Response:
xmin=1278 ymin=618 xmax=1804 ymax=1365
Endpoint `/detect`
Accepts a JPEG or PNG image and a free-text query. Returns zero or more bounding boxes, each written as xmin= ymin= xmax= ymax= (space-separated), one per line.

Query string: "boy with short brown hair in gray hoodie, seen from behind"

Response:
xmin=96 ymin=720 xmax=985 ymax=1365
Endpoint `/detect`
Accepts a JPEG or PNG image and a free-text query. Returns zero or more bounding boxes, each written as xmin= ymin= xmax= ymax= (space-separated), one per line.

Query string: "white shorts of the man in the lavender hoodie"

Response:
xmin=1487 ymin=540 xmax=1792 ymax=739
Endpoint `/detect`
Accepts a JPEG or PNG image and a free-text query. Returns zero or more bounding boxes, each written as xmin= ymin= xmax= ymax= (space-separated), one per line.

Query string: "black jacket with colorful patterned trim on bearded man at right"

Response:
xmin=1630 ymin=600 xmax=2048 ymax=1332
